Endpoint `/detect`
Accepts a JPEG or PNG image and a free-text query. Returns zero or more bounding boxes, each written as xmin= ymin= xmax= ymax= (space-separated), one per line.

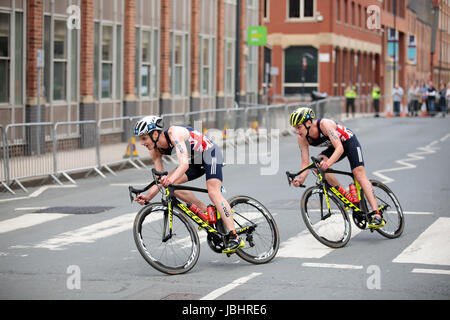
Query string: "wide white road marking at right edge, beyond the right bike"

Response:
xmin=393 ymin=217 xmax=450 ymax=266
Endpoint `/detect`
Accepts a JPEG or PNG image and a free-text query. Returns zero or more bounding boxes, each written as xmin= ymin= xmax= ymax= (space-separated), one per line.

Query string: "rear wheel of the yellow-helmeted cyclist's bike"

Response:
xmin=361 ymin=179 xmax=405 ymax=239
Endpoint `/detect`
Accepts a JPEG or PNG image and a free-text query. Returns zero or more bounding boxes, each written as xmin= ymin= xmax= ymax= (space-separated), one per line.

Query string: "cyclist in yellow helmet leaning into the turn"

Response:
xmin=289 ymin=107 xmax=385 ymax=228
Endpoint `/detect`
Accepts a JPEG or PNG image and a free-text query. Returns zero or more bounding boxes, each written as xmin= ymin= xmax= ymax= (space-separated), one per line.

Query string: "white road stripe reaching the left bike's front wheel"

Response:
xmin=32 ymin=212 xmax=136 ymax=250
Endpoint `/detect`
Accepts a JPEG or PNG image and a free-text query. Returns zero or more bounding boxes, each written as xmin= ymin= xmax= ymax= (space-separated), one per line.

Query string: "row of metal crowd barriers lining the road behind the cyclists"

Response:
xmin=0 ymin=97 xmax=372 ymax=193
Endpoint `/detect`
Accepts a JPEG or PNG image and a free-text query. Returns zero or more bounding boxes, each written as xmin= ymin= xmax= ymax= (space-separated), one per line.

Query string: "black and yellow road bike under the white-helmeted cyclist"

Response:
xmin=128 ymin=169 xmax=280 ymax=274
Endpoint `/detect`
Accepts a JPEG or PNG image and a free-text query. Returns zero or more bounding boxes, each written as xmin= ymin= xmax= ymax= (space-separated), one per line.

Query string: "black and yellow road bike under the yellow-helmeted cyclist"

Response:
xmin=286 ymin=157 xmax=405 ymax=248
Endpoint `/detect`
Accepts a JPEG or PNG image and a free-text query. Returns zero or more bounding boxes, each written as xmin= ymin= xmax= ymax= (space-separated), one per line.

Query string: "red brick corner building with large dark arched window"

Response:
xmin=263 ymin=0 xmax=448 ymax=110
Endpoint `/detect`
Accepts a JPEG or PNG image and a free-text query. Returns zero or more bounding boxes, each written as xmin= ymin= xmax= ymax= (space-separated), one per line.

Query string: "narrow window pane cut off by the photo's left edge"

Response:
xmin=0 ymin=13 xmax=9 ymax=103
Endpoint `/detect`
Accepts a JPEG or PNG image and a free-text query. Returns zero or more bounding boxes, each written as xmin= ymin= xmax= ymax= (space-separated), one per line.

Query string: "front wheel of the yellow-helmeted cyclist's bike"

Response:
xmin=301 ymin=187 xmax=351 ymax=248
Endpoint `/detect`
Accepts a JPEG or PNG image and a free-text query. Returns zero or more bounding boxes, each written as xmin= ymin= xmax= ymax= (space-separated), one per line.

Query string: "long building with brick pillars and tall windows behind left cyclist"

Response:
xmin=0 ymin=0 xmax=263 ymax=130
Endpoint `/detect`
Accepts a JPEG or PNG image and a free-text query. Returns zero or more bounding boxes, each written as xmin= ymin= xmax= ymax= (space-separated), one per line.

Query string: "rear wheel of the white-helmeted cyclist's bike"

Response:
xmin=228 ymin=196 xmax=280 ymax=264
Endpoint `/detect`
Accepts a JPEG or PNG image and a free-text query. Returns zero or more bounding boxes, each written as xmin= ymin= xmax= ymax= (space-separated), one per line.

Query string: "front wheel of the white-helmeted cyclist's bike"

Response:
xmin=133 ymin=203 xmax=200 ymax=274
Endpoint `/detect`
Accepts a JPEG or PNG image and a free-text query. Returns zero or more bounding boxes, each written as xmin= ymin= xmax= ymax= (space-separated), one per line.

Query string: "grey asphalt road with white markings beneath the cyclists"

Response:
xmin=0 ymin=118 xmax=450 ymax=301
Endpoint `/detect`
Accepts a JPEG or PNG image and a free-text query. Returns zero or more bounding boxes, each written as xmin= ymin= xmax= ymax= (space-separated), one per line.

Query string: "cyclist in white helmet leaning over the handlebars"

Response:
xmin=134 ymin=116 xmax=245 ymax=253
